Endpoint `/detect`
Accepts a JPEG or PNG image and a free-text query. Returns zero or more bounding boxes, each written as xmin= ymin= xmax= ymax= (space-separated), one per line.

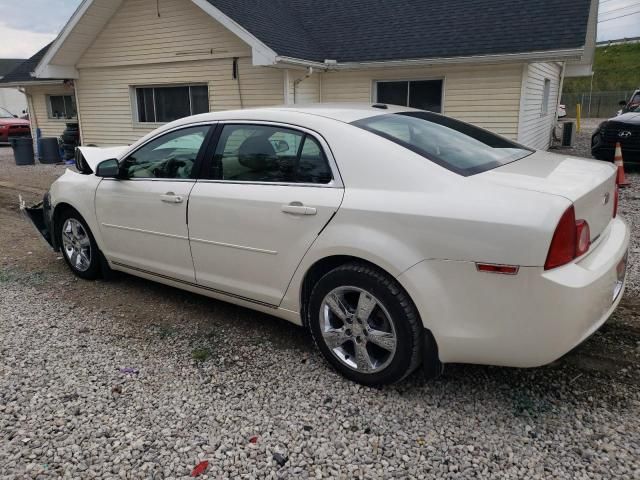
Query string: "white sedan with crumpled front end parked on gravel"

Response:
xmin=25 ymin=105 xmax=629 ymax=385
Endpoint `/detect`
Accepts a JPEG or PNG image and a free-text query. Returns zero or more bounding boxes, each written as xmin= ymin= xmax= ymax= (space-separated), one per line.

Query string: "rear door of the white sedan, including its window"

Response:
xmin=189 ymin=123 xmax=344 ymax=305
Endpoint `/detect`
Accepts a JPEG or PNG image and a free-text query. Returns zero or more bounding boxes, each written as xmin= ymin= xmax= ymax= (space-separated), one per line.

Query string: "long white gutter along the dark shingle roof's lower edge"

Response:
xmin=276 ymin=47 xmax=584 ymax=70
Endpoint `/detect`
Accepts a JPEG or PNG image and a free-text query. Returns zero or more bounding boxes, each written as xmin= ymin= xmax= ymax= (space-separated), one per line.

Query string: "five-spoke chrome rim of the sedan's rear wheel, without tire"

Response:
xmin=320 ymin=287 xmax=398 ymax=374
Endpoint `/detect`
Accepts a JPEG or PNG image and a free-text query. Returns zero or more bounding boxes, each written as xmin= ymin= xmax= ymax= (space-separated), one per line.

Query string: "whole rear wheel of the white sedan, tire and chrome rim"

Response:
xmin=307 ymin=262 xmax=424 ymax=386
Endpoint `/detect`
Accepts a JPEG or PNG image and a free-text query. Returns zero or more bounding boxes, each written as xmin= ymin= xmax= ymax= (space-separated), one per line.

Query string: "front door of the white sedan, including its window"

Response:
xmin=96 ymin=125 xmax=212 ymax=282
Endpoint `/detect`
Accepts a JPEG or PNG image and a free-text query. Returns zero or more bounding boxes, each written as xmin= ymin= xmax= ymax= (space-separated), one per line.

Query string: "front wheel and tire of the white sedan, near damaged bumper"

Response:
xmin=56 ymin=209 xmax=100 ymax=280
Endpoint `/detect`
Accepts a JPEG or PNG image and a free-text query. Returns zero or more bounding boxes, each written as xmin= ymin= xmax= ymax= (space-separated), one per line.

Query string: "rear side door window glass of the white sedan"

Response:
xmin=210 ymin=125 xmax=332 ymax=184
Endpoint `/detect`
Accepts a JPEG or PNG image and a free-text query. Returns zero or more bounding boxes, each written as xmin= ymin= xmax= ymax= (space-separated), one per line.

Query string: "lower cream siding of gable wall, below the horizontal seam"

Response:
xmin=76 ymin=58 xmax=284 ymax=146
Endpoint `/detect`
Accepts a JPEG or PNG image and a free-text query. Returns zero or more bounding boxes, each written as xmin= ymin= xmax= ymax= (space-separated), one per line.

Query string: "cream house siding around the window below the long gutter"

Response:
xmin=322 ymin=64 xmax=522 ymax=139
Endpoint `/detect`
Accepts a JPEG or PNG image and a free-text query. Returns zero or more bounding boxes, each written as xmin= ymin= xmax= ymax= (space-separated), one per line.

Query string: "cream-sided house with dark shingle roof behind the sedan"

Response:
xmin=0 ymin=0 xmax=597 ymax=149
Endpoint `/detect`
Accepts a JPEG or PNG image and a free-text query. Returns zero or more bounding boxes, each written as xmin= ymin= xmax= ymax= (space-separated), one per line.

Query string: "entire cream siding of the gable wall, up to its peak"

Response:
xmin=76 ymin=0 xmax=284 ymax=146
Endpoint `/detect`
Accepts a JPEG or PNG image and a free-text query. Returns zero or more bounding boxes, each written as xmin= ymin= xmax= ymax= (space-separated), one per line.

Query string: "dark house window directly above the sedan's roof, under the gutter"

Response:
xmin=376 ymin=80 xmax=443 ymax=113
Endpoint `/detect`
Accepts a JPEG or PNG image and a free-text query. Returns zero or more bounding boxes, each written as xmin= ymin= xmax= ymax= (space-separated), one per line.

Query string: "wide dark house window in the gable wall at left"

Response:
xmin=135 ymin=85 xmax=209 ymax=123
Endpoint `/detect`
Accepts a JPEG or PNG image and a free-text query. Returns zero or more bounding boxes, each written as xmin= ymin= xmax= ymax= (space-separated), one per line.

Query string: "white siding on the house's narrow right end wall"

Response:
xmin=518 ymin=63 xmax=562 ymax=150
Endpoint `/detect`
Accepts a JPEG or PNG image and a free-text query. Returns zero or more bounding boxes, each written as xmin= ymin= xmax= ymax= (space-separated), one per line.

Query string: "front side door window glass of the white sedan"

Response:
xmin=121 ymin=125 xmax=210 ymax=179
